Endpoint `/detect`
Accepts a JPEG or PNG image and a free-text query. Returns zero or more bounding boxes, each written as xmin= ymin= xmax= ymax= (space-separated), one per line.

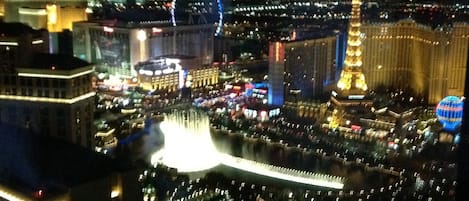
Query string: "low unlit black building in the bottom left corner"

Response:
xmin=0 ymin=124 xmax=142 ymax=201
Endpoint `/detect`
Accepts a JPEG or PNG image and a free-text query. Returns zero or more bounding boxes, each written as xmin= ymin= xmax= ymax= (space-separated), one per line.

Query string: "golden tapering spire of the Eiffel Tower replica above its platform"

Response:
xmin=337 ymin=0 xmax=368 ymax=93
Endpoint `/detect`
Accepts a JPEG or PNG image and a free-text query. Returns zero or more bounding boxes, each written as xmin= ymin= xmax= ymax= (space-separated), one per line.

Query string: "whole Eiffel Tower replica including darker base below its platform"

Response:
xmin=329 ymin=0 xmax=373 ymax=128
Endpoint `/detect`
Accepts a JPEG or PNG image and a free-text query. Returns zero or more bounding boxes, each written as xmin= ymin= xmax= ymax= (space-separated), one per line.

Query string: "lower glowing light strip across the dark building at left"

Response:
xmin=0 ymin=92 xmax=96 ymax=104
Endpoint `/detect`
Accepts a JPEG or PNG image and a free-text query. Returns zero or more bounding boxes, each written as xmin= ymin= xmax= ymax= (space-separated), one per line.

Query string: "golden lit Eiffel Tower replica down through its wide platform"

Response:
xmin=331 ymin=0 xmax=372 ymax=106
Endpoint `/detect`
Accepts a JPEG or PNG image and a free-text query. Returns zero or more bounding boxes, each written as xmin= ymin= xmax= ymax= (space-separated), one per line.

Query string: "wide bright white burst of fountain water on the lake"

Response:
xmin=151 ymin=109 xmax=220 ymax=172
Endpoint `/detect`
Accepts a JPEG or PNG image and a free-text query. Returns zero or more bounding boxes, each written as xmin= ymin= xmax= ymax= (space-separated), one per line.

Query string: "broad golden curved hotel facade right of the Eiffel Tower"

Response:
xmin=362 ymin=19 xmax=469 ymax=104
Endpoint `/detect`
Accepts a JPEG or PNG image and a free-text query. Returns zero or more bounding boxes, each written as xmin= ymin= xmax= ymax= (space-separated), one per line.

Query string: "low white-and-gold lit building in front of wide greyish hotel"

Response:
xmin=135 ymin=57 xmax=219 ymax=92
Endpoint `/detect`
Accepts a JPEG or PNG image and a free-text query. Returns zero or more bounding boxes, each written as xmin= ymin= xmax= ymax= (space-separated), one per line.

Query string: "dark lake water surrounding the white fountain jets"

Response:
xmin=116 ymin=121 xmax=393 ymax=190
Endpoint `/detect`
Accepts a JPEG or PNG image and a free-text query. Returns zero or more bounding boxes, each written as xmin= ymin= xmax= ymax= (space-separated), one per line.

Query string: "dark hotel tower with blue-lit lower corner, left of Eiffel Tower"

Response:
xmin=268 ymin=36 xmax=337 ymax=105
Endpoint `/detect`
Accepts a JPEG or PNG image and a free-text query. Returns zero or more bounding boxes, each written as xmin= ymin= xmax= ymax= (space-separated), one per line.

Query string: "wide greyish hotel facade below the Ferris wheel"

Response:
xmin=73 ymin=21 xmax=214 ymax=77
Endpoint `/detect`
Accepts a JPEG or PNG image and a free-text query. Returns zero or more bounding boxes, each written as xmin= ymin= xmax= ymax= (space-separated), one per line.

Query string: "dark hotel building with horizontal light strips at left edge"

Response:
xmin=0 ymin=23 xmax=95 ymax=148
